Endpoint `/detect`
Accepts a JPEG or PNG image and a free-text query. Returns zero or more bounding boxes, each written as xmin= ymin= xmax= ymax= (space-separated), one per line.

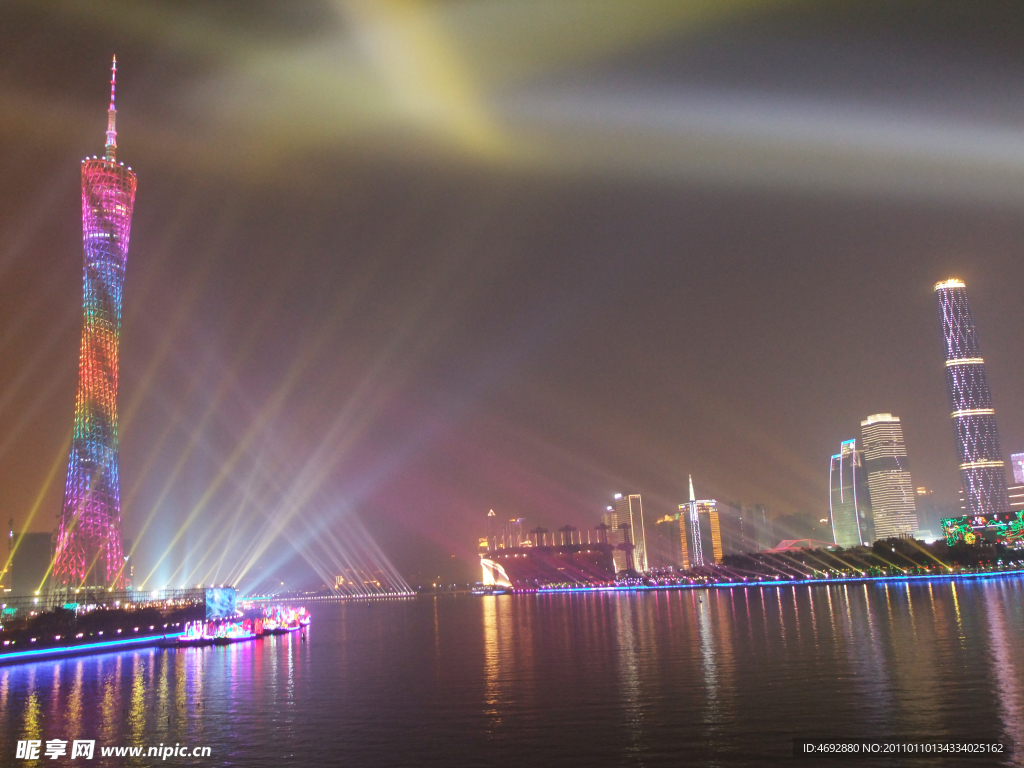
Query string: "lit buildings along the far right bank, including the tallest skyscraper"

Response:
xmin=480 ymin=280 xmax=1024 ymax=581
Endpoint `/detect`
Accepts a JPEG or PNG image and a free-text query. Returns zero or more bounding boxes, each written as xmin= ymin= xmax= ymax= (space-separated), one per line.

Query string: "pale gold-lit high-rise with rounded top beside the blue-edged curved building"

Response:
xmin=860 ymin=414 xmax=918 ymax=539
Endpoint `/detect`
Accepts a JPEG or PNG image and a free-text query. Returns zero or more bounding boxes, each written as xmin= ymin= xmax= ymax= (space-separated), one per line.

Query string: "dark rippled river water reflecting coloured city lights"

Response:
xmin=0 ymin=578 xmax=1024 ymax=767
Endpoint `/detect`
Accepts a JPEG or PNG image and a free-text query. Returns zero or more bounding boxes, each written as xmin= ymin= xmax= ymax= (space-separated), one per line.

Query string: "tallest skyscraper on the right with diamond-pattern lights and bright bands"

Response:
xmin=935 ymin=280 xmax=1009 ymax=517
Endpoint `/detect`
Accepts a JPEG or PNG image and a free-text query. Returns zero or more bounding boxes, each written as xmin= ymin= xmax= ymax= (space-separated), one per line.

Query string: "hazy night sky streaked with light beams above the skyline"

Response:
xmin=0 ymin=0 xmax=1024 ymax=586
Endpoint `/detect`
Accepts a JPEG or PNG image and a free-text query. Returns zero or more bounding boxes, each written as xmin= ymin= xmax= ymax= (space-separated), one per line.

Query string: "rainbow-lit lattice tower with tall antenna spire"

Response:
xmin=52 ymin=56 xmax=135 ymax=590
